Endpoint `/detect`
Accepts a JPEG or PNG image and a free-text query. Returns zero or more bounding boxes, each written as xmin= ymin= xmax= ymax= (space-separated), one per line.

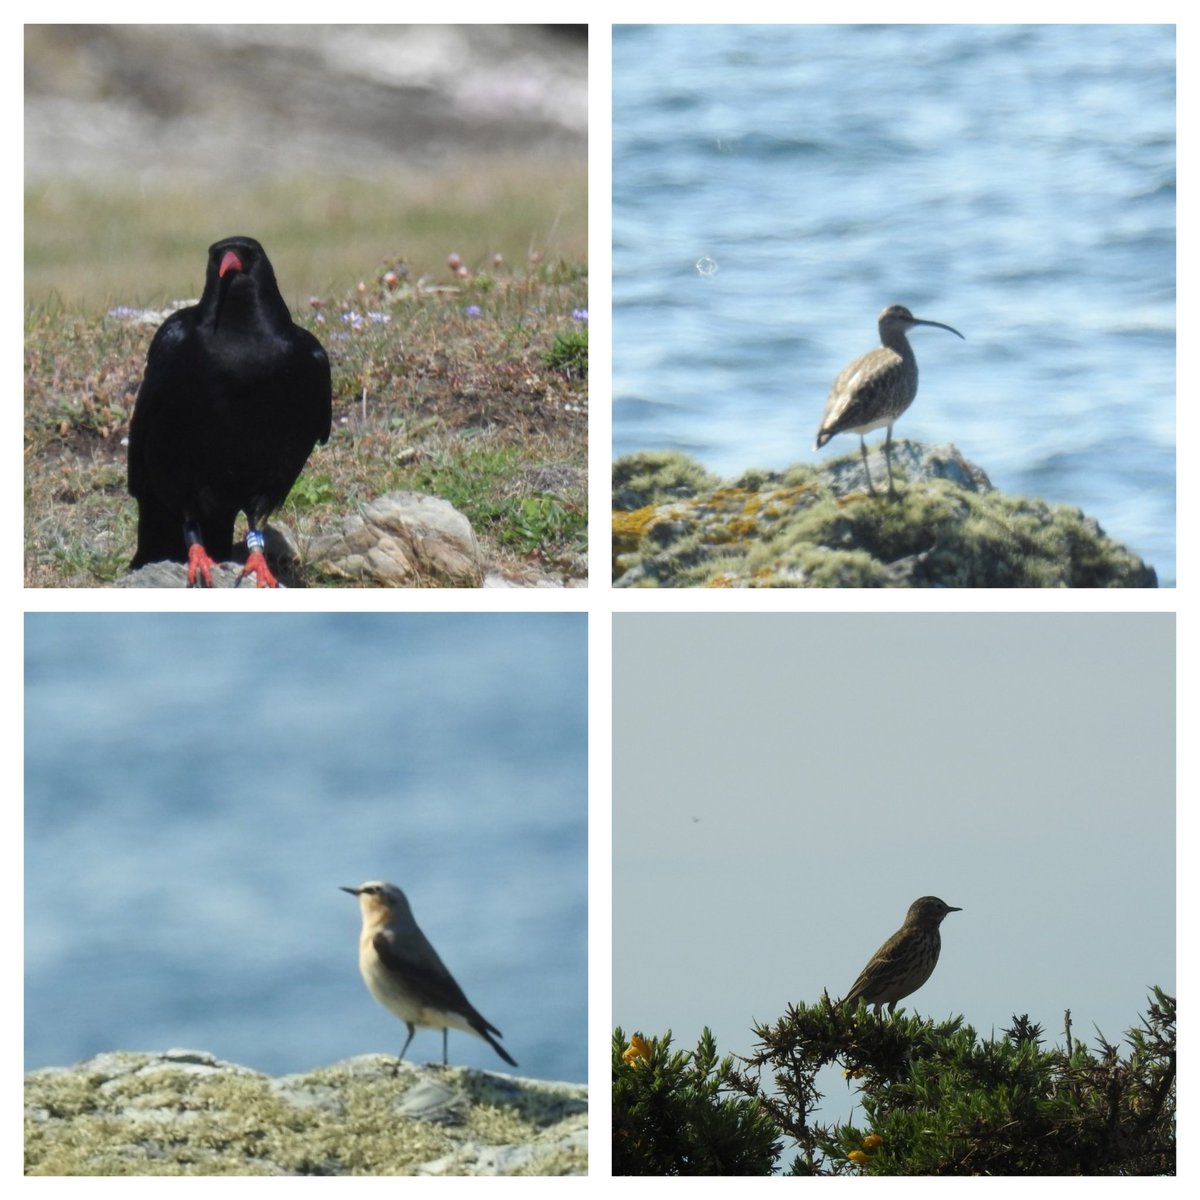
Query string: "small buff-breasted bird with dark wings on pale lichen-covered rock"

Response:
xmin=342 ymin=881 xmax=517 ymax=1067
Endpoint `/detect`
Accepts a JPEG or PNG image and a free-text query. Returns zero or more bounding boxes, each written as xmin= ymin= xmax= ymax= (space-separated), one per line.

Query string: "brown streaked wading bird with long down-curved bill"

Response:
xmin=812 ymin=304 xmax=966 ymax=496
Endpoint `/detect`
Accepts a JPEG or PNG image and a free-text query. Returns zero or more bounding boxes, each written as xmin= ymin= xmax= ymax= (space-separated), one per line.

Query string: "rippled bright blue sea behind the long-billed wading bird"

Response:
xmin=612 ymin=25 xmax=1175 ymax=584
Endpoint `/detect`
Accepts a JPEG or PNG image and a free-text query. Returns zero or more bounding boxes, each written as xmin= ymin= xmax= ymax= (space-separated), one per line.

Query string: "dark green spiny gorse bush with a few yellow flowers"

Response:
xmin=613 ymin=988 xmax=1176 ymax=1176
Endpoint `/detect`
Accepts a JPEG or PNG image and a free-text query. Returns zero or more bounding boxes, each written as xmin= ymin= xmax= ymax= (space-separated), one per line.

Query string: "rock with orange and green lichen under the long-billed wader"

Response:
xmin=612 ymin=442 xmax=1158 ymax=588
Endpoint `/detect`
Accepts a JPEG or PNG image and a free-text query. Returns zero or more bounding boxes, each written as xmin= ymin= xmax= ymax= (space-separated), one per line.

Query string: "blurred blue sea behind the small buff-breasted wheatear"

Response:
xmin=25 ymin=613 xmax=588 ymax=1081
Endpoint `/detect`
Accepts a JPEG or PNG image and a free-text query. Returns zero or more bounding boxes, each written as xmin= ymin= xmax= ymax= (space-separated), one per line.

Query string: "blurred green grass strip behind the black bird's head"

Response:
xmin=25 ymin=160 xmax=587 ymax=311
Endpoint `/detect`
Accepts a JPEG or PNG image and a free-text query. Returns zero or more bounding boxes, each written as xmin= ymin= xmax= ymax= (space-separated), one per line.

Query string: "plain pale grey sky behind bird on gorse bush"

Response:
xmin=612 ymin=612 xmax=1175 ymax=1115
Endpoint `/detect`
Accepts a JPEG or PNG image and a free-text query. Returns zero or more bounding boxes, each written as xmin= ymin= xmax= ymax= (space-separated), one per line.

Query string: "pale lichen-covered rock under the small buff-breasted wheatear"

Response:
xmin=25 ymin=1050 xmax=588 ymax=1175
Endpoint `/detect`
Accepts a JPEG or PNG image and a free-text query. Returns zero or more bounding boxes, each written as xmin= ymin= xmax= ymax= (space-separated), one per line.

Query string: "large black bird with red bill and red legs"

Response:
xmin=128 ymin=238 xmax=332 ymax=588
